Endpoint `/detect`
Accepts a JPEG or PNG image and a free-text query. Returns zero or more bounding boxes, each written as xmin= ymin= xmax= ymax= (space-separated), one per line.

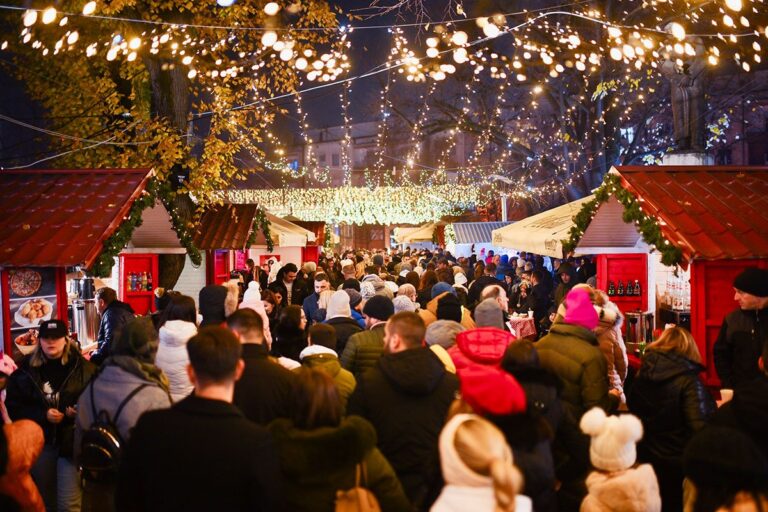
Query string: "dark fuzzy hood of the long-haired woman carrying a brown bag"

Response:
xmin=269 ymin=416 xmax=376 ymax=477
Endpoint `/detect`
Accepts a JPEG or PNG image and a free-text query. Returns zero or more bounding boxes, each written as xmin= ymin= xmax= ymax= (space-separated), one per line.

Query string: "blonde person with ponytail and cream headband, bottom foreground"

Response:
xmin=431 ymin=414 xmax=532 ymax=512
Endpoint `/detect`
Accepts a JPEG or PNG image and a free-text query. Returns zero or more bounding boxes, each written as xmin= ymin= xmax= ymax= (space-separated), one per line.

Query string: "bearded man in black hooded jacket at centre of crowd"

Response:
xmin=348 ymin=312 xmax=459 ymax=507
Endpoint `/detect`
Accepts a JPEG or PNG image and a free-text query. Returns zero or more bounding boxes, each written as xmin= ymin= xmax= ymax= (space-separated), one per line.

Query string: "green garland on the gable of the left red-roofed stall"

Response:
xmin=90 ymin=178 xmax=202 ymax=277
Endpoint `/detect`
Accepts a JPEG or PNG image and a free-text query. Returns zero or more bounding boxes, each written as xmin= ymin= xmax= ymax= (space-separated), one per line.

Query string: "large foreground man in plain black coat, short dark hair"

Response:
xmin=115 ymin=326 xmax=283 ymax=512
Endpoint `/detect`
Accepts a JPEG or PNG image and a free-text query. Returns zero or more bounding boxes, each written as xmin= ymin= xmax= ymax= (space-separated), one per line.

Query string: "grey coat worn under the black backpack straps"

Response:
xmin=75 ymin=365 xmax=171 ymax=458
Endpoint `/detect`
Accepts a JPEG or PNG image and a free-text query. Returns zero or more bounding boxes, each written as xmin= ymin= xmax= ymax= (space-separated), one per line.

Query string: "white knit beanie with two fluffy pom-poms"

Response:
xmin=581 ymin=407 xmax=643 ymax=471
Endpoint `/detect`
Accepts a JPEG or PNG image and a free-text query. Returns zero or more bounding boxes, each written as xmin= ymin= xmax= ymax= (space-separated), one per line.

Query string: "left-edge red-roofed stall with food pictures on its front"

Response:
xmin=0 ymin=169 xmax=151 ymax=356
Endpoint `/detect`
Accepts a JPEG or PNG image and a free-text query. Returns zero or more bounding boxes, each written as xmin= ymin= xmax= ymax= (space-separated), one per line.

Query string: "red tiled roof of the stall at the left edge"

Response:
xmin=0 ymin=169 xmax=151 ymax=267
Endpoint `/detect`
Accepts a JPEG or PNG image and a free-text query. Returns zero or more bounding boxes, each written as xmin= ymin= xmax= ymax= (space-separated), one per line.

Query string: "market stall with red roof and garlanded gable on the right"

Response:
xmin=570 ymin=166 xmax=768 ymax=386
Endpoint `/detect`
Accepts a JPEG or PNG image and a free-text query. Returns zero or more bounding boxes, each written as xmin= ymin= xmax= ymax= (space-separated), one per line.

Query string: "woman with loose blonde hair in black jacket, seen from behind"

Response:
xmin=627 ymin=327 xmax=715 ymax=510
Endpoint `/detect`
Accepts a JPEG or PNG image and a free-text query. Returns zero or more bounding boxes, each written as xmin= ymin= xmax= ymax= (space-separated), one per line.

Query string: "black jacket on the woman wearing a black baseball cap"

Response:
xmin=5 ymin=344 xmax=96 ymax=457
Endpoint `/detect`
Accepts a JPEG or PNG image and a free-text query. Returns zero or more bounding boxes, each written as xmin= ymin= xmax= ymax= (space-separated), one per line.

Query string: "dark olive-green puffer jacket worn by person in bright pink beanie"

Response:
xmin=536 ymin=323 xmax=618 ymax=421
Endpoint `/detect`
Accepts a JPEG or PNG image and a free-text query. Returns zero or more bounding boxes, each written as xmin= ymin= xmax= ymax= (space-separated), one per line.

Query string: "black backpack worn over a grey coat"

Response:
xmin=79 ymin=380 xmax=149 ymax=482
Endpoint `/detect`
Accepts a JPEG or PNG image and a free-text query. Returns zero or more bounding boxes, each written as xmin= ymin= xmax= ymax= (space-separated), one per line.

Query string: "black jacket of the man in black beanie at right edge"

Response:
xmin=713 ymin=308 xmax=768 ymax=389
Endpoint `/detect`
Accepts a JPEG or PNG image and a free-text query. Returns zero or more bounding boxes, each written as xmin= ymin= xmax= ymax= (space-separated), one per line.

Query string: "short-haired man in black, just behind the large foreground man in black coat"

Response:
xmin=227 ymin=308 xmax=296 ymax=426
